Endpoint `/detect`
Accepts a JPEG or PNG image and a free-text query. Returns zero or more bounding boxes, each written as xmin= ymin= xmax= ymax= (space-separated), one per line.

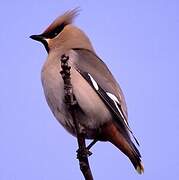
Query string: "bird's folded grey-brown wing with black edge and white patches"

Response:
xmin=73 ymin=49 xmax=139 ymax=145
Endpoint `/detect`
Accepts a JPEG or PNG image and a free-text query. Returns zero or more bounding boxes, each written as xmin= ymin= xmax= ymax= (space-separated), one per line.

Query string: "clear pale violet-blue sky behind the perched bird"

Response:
xmin=0 ymin=0 xmax=179 ymax=180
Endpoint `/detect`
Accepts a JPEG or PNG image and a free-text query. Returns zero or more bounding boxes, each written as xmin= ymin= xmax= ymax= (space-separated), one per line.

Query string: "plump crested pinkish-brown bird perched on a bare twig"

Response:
xmin=30 ymin=8 xmax=144 ymax=174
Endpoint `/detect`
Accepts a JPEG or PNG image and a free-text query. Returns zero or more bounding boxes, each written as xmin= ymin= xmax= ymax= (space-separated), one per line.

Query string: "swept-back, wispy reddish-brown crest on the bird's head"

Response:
xmin=42 ymin=7 xmax=80 ymax=37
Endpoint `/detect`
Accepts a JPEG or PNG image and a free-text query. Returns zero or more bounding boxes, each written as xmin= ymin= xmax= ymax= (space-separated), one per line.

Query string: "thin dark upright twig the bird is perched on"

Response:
xmin=60 ymin=54 xmax=93 ymax=180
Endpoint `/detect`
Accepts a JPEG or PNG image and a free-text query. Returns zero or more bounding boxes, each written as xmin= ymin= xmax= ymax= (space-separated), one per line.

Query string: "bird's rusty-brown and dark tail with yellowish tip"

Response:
xmin=102 ymin=123 xmax=144 ymax=174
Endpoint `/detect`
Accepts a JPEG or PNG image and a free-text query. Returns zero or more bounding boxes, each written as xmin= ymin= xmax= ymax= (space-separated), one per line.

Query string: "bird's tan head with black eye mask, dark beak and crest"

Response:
xmin=30 ymin=8 xmax=93 ymax=53
